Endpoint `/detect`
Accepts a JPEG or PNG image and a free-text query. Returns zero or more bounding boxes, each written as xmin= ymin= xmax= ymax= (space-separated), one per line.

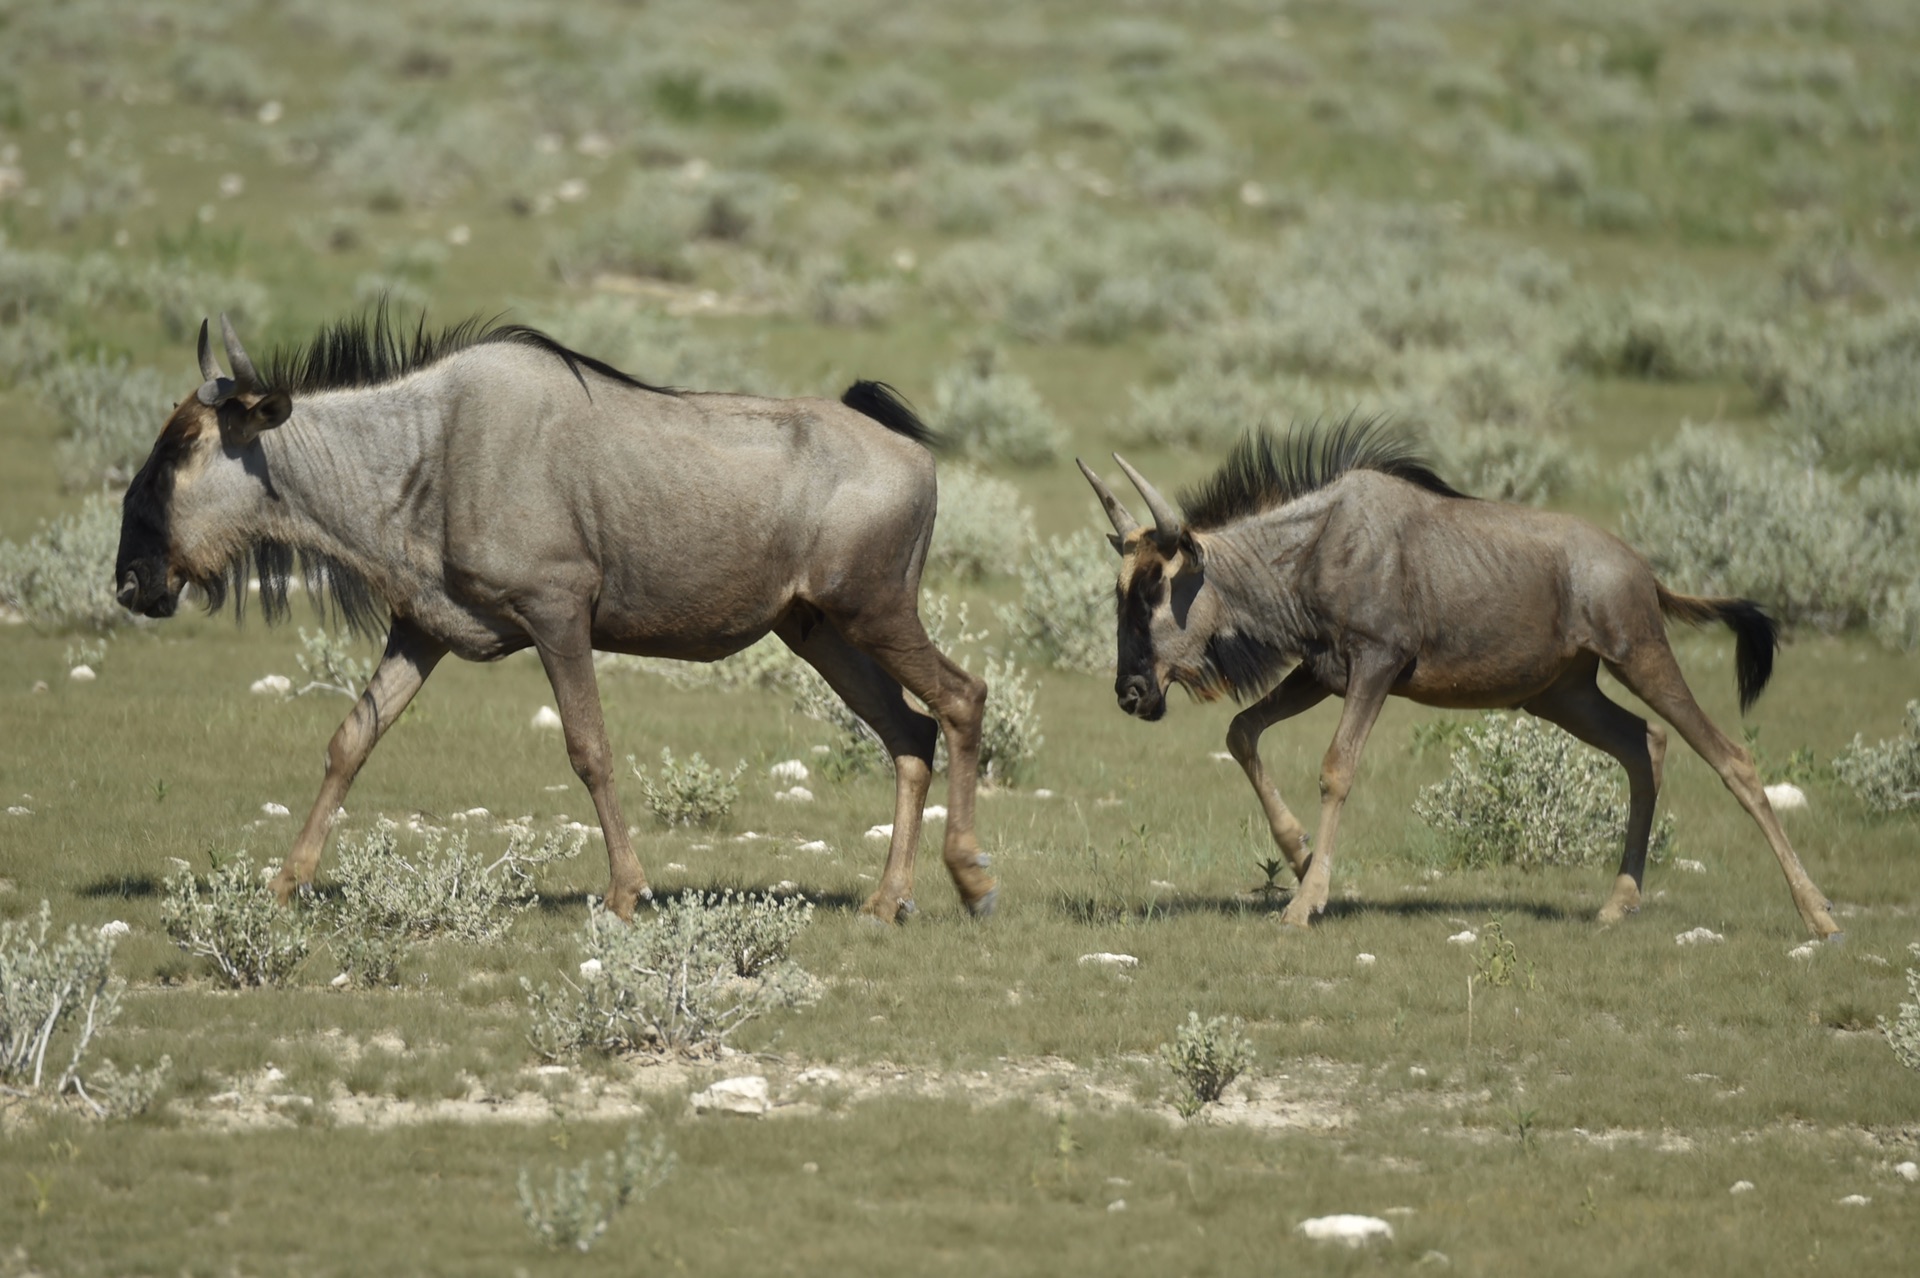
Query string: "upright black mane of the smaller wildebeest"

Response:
xmin=1181 ymin=416 xmax=1467 ymax=530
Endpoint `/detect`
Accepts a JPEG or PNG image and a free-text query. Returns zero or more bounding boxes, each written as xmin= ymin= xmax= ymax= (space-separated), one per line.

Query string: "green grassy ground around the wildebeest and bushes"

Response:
xmin=0 ymin=0 xmax=1920 ymax=1276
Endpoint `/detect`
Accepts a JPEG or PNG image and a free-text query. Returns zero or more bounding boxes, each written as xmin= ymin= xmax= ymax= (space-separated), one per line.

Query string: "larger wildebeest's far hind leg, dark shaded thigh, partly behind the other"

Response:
xmin=776 ymin=618 xmax=939 ymax=923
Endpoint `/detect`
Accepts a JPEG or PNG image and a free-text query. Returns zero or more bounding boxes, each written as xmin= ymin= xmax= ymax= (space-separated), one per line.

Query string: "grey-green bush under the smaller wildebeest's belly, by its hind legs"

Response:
xmin=1413 ymin=714 xmax=1674 ymax=869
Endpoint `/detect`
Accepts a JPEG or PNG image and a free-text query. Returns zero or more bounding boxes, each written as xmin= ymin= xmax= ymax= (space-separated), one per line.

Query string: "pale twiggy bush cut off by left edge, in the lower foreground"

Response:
xmin=0 ymin=900 xmax=125 ymax=1096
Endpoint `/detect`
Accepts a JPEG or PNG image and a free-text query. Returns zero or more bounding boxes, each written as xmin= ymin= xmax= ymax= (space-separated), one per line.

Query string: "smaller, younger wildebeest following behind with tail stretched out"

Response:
xmin=1081 ymin=422 xmax=1839 ymax=936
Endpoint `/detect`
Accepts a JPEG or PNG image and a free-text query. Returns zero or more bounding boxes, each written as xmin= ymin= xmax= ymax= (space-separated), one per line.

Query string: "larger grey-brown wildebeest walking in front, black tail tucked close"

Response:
xmin=113 ymin=309 xmax=995 ymax=921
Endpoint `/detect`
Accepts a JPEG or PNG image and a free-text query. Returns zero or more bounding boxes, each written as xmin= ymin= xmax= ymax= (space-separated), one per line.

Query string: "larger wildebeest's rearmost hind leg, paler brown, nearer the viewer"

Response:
xmin=841 ymin=610 xmax=995 ymax=915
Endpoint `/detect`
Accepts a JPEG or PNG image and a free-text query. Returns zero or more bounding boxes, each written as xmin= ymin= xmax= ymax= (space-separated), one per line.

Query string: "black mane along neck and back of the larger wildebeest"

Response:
xmin=263 ymin=301 xmax=674 ymax=395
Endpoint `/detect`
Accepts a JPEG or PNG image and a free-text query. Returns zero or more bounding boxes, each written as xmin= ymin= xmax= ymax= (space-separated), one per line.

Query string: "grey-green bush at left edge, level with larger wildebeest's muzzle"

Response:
xmin=0 ymin=497 xmax=132 ymax=629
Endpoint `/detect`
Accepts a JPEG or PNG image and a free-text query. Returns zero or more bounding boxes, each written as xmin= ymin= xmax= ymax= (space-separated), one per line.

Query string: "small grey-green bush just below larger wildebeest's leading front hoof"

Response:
xmin=159 ymin=852 xmax=315 ymax=990
